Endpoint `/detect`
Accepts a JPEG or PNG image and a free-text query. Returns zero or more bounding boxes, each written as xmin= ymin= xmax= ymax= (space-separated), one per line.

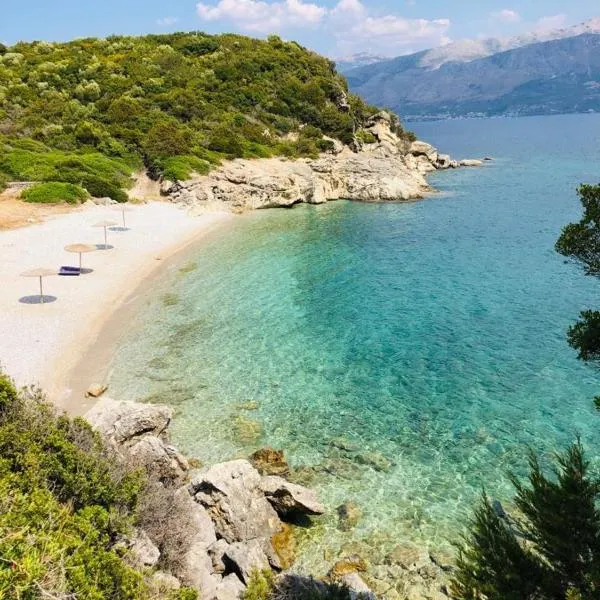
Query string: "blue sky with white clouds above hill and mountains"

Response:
xmin=0 ymin=0 xmax=600 ymax=58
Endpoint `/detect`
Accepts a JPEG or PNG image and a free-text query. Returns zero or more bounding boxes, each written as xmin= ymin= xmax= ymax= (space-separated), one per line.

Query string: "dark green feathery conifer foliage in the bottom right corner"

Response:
xmin=453 ymin=442 xmax=600 ymax=600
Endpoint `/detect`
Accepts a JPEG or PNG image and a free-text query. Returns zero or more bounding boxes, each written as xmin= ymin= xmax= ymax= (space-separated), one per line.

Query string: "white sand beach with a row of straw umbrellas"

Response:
xmin=0 ymin=202 xmax=233 ymax=404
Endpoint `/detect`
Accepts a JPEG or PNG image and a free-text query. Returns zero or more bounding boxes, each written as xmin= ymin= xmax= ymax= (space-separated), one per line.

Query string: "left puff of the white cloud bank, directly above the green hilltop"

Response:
xmin=196 ymin=0 xmax=327 ymax=33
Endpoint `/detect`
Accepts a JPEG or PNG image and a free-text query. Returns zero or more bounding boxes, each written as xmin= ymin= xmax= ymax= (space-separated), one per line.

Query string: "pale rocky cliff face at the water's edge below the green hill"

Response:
xmin=162 ymin=112 xmax=472 ymax=212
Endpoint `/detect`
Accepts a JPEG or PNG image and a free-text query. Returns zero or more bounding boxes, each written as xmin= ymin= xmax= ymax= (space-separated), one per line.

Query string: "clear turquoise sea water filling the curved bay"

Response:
xmin=111 ymin=115 xmax=600 ymax=570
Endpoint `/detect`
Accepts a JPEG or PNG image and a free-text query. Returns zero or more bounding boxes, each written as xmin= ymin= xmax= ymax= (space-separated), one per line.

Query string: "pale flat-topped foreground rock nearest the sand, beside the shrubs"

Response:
xmin=85 ymin=398 xmax=172 ymax=444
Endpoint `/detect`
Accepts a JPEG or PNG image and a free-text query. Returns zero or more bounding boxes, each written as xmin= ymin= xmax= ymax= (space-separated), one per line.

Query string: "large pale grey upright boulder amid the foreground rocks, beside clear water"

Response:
xmin=189 ymin=460 xmax=280 ymax=543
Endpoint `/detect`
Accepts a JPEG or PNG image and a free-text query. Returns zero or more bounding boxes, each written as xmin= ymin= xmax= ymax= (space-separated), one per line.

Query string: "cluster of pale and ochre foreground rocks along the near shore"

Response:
xmin=86 ymin=398 xmax=452 ymax=600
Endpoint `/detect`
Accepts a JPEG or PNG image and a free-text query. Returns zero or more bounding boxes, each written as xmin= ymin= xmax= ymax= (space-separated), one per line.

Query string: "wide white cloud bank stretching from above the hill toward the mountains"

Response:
xmin=196 ymin=0 xmax=451 ymax=55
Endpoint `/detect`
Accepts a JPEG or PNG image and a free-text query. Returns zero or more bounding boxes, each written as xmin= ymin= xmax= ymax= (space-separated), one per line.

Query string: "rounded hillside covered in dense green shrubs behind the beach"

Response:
xmin=0 ymin=33 xmax=384 ymax=200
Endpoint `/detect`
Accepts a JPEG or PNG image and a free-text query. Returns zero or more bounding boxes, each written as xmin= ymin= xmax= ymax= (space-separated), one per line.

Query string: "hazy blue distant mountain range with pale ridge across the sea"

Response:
xmin=338 ymin=18 xmax=600 ymax=120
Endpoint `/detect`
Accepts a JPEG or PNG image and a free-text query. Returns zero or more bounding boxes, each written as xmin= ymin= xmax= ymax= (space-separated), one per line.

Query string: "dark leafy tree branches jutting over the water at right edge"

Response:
xmin=556 ymin=185 xmax=600 ymax=360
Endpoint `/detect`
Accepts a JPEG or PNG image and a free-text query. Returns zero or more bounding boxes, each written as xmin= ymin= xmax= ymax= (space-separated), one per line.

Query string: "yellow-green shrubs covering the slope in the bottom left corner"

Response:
xmin=0 ymin=374 xmax=195 ymax=600
